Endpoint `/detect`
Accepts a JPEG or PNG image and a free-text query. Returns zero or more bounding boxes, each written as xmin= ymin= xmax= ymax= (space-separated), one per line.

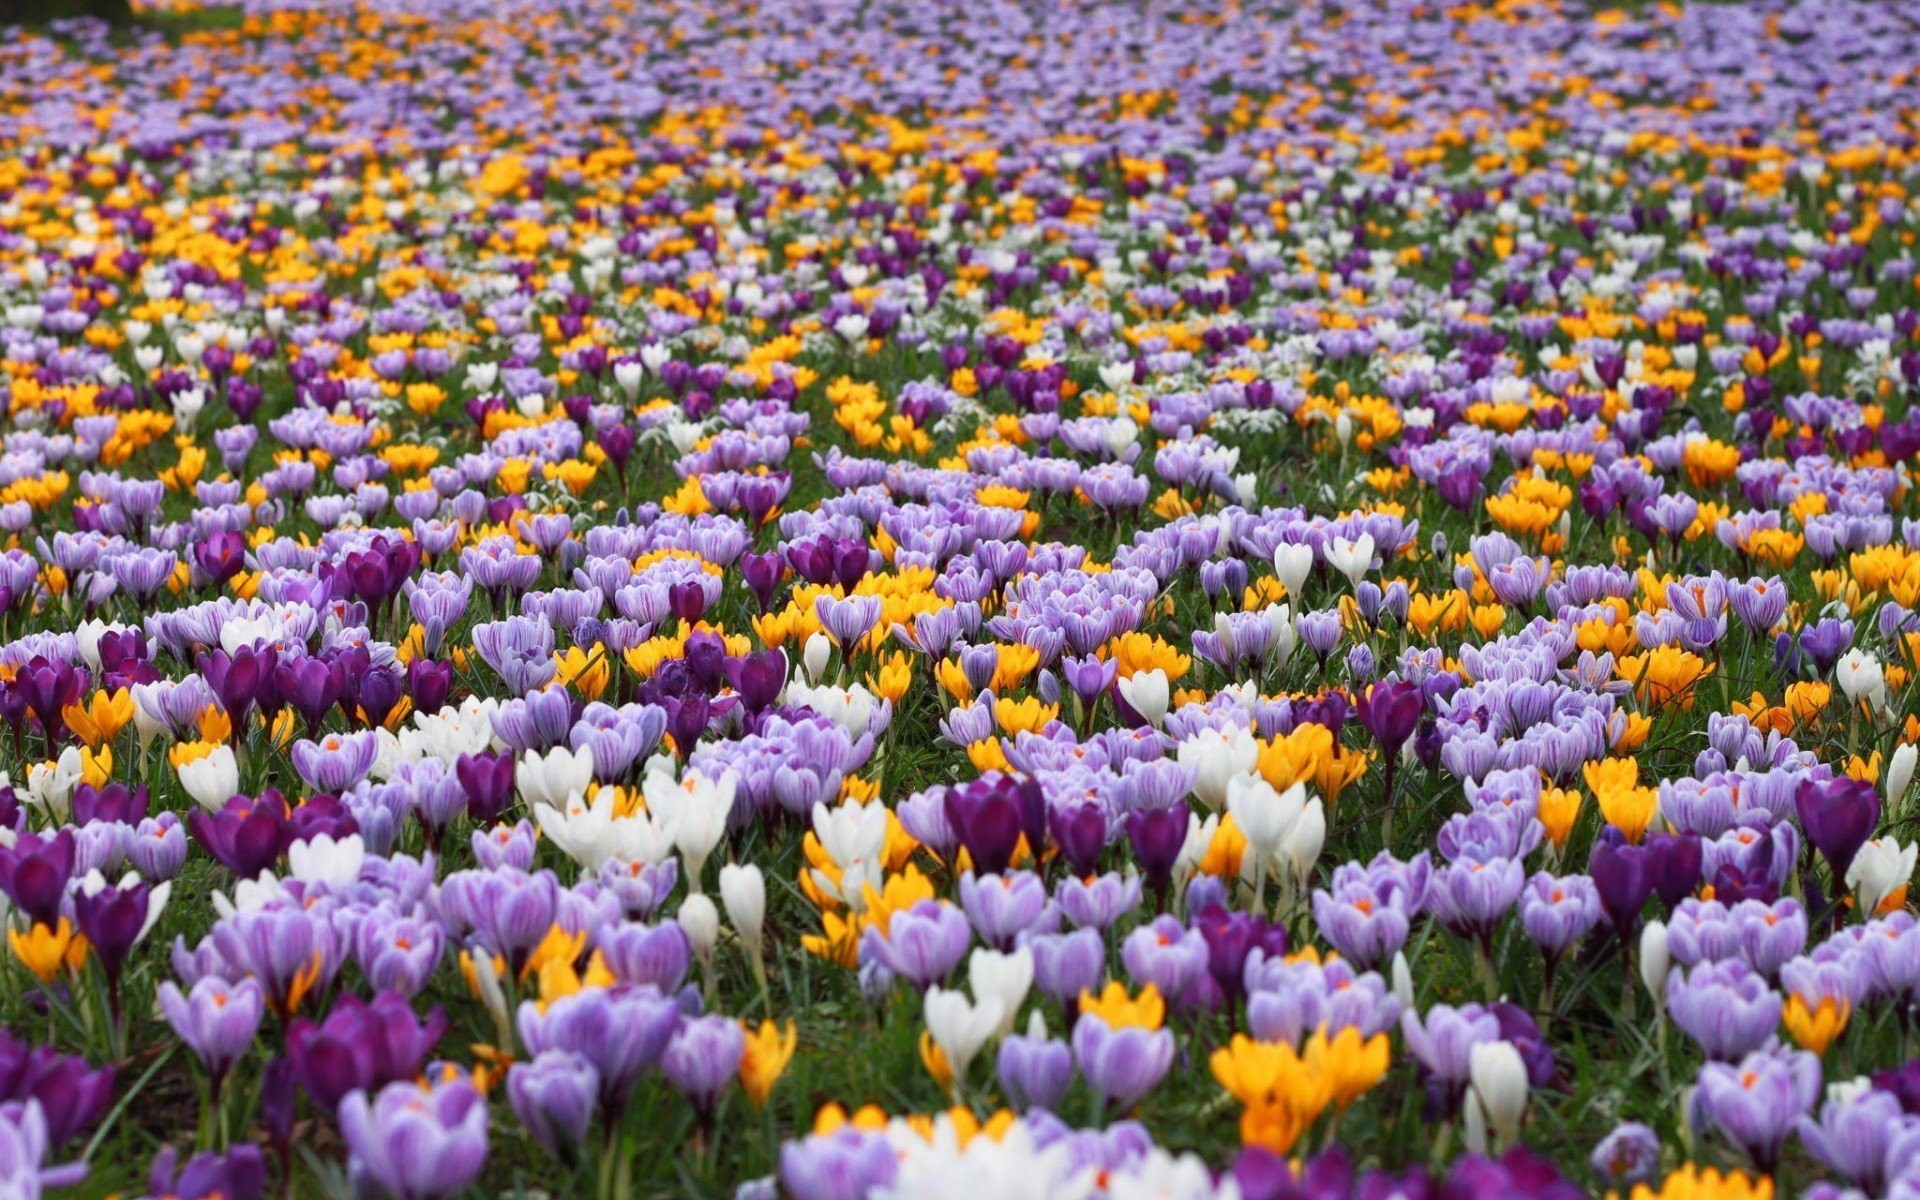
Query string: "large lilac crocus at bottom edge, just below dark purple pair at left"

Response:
xmin=340 ymin=1077 xmax=488 ymax=1200
